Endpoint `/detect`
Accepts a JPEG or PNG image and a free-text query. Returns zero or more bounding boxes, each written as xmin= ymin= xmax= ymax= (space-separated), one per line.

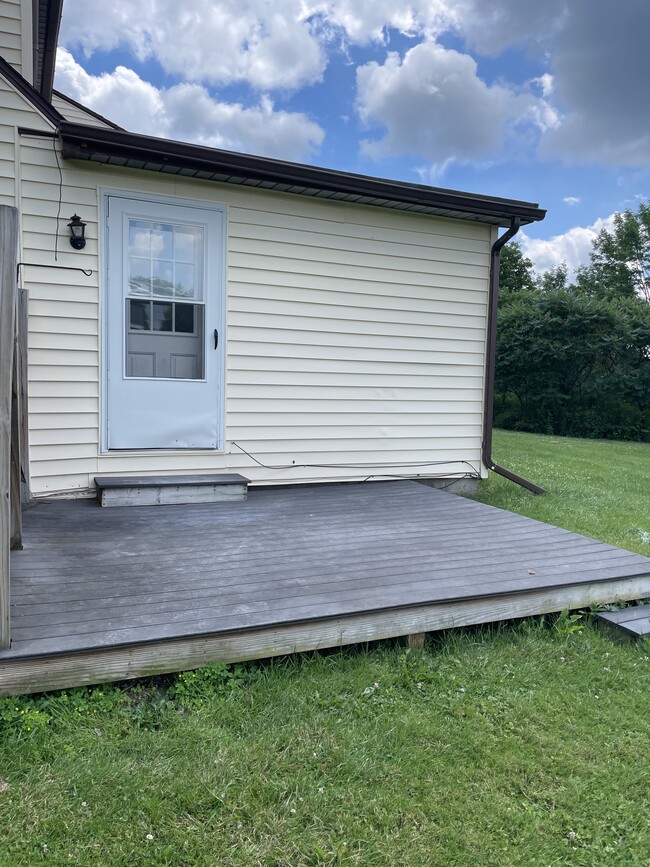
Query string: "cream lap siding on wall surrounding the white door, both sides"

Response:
xmin=15 ymin=139 xmax=491 ymax=494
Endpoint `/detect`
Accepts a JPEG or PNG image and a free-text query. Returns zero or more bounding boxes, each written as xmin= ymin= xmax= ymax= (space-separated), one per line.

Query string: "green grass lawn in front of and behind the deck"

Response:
xmin=0 ymin=433 xmax=650 ymax=867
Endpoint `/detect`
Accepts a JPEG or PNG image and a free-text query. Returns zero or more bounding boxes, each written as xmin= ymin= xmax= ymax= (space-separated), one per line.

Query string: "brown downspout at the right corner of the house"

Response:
xmin=482 ymin=217 xmax=546 ymax=494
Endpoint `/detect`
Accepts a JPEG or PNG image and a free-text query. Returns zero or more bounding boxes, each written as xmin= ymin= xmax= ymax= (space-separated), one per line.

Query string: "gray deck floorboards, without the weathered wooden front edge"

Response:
xmin=0 ymin=481 xmax=650 ymax=661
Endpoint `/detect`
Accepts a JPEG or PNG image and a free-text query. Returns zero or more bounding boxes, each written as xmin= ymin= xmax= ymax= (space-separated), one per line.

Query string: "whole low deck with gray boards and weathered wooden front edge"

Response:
xmin=0 ymin=481 xmax=650 ymax=694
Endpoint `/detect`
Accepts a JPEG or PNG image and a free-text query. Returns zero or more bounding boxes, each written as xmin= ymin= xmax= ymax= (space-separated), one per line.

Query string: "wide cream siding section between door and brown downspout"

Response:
xmin=228 ymin=205 xmax=490 ymax=478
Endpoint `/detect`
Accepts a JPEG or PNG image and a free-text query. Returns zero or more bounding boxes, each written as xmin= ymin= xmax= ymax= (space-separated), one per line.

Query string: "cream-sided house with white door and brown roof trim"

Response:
xmin=0 ymin=0 xmax=545 ymax=508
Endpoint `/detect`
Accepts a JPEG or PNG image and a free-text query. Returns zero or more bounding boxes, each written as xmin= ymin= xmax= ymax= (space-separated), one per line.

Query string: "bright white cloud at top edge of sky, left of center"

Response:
xmin=59 ymin=0 xmax=326 ymax=90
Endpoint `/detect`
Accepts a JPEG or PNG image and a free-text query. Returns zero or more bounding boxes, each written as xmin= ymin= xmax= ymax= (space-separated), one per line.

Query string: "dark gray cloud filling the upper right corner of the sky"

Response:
xmin=436 ymin=0 xmax=650 ymax=166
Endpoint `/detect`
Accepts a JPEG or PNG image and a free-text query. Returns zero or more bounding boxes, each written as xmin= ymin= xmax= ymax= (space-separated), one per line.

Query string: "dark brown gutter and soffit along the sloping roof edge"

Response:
xmin=59 ymin=121 xmax=546 ymax=226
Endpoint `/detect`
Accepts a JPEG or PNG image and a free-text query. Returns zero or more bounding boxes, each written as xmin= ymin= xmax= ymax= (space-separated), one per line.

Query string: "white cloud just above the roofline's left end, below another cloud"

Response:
xmin=56 ymin=49 xmax=324 ymax=160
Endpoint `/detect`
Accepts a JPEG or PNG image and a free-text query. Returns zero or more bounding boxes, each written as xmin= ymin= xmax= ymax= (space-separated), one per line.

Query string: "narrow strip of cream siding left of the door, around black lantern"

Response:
xmin=20 ymin=137 xmax=100 ymax=495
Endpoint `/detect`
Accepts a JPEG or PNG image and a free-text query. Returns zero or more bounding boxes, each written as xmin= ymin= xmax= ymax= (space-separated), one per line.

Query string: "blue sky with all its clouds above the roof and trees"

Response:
xmin=55 ymin=0 xmax=650 ymax=272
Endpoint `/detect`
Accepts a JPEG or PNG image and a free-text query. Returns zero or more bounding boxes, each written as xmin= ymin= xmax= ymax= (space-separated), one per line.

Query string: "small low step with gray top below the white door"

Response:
xmin=95 ymin=473 xmax=250 ymax=506
